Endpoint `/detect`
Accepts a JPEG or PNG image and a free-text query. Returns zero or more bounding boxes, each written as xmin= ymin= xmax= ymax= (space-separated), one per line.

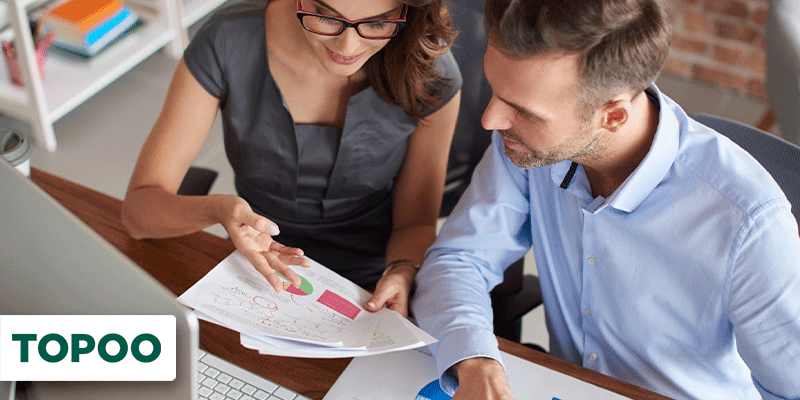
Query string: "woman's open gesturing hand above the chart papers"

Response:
xmin=217 ymin=195 xmax=309 ymax=292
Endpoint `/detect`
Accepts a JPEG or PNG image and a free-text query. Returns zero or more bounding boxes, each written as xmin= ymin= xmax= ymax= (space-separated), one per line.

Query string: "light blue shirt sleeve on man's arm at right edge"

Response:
xmin=729 ymin=200 xmax=800 ymax=399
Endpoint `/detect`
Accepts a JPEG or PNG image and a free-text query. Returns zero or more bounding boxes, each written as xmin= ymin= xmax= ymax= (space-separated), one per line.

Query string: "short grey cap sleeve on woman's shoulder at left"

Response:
xmin=183 ymin=15 xmax=225 ymax=99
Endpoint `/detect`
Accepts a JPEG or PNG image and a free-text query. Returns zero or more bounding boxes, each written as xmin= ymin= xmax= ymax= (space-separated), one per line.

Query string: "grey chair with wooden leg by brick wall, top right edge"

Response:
xmin=759 ymin=0 xmax=800 ymax=144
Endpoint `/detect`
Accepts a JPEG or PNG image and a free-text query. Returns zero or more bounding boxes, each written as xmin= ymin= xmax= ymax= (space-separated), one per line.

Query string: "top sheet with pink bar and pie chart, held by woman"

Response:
xmin=178 ymin=251 xmax=378 ymax=348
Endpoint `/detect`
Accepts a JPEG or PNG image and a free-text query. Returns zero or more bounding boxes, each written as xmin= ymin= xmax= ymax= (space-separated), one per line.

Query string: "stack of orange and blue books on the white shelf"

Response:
xmin=39 ymin=0 xmax=139 ymax=57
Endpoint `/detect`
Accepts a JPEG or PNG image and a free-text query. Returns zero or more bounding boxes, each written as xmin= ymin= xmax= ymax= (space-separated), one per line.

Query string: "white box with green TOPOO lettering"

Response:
xmin=0 ymin=315 xmax=176 ymax=381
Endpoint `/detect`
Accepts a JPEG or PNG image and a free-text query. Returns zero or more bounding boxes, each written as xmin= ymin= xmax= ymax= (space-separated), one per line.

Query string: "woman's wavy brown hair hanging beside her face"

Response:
xmin=365 ymin=0 xmax=456 ymax=118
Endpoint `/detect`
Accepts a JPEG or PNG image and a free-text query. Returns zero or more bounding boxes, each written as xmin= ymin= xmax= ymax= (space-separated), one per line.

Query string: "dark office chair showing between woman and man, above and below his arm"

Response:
xmin=439 ymin=0 xmax=542 ymax=342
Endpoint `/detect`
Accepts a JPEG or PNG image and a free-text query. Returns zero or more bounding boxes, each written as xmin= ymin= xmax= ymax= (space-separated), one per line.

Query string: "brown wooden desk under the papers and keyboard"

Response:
xmin=31 ymin=168 xmax=666 ymax=400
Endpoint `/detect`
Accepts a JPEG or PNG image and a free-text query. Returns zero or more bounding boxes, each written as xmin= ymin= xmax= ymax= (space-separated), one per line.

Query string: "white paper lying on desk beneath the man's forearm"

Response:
xmin=323 ymin=348 xmax=627 ymax=400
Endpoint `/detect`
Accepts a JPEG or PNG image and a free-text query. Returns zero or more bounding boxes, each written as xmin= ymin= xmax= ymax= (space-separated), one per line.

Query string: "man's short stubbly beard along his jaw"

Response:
xmin=498 ymin=124 xmax=598 ymax=169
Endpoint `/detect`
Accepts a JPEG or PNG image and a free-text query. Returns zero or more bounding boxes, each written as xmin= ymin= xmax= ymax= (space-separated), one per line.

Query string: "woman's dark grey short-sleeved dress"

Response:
xmin=184 ymin=2 xmax=461 ymax=290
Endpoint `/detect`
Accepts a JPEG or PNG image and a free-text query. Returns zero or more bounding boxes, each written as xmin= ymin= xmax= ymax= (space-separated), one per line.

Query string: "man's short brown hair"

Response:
xmin=485 ymin=0 xmax=670 ymax=118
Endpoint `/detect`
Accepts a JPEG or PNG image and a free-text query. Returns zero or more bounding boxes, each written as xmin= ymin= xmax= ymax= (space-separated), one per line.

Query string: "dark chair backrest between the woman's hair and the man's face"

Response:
xmin=439 ymin=0 xmax=492 ymax=217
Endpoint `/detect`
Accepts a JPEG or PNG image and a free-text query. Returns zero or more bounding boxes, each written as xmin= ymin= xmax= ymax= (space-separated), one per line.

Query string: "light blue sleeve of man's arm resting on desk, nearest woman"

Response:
xmin=411 ymin=132 xmax=531 ymax=395
